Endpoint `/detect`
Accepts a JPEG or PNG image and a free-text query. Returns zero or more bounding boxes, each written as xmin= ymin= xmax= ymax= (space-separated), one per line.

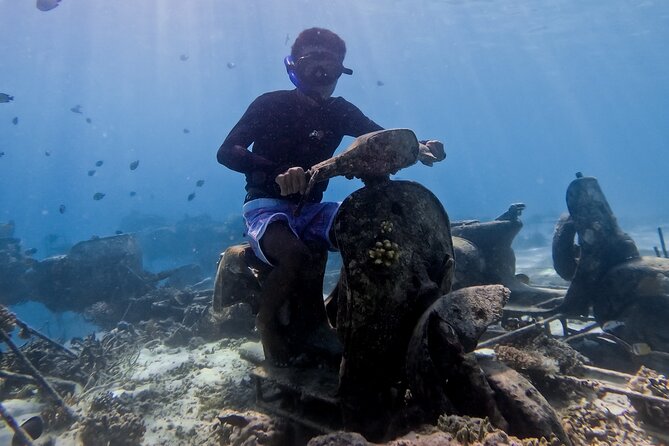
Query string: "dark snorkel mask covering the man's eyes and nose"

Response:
xmin=283 ymin=51 xmax=353 ymax=92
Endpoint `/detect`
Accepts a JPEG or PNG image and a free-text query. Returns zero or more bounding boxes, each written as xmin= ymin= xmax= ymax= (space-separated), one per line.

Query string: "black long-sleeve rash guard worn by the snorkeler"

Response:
xmin=217 ymin=89 xmax=383 ymax=202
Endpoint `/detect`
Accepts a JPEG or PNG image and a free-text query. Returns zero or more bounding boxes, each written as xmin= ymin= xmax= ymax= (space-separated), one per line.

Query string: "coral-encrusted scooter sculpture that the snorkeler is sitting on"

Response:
xmin=212 ymin=129 xmax=569 ymax=444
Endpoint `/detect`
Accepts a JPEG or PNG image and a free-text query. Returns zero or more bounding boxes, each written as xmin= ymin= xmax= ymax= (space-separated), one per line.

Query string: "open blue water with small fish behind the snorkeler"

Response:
xmin=0 ymin=0 xmax=669 ymax=332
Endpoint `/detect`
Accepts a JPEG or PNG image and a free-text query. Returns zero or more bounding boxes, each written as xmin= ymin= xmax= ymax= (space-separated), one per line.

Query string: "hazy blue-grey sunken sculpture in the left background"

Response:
xmin=0 ymin=231 xmax=214 ymax=328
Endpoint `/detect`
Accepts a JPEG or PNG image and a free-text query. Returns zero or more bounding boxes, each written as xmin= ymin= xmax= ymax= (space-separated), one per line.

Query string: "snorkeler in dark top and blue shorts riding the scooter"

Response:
xmin=217 ymin=28 xmax=446 ymax=365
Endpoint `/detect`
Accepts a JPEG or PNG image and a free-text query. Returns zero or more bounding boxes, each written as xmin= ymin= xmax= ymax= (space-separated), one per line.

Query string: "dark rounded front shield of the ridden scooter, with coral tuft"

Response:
xmin=335 ymin=180 xmax=454 ymax=433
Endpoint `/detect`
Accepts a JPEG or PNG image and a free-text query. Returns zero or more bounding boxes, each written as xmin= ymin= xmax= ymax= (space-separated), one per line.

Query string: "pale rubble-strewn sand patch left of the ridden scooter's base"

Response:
xmin=35 ymin=340 xmax=253 ymax=446
